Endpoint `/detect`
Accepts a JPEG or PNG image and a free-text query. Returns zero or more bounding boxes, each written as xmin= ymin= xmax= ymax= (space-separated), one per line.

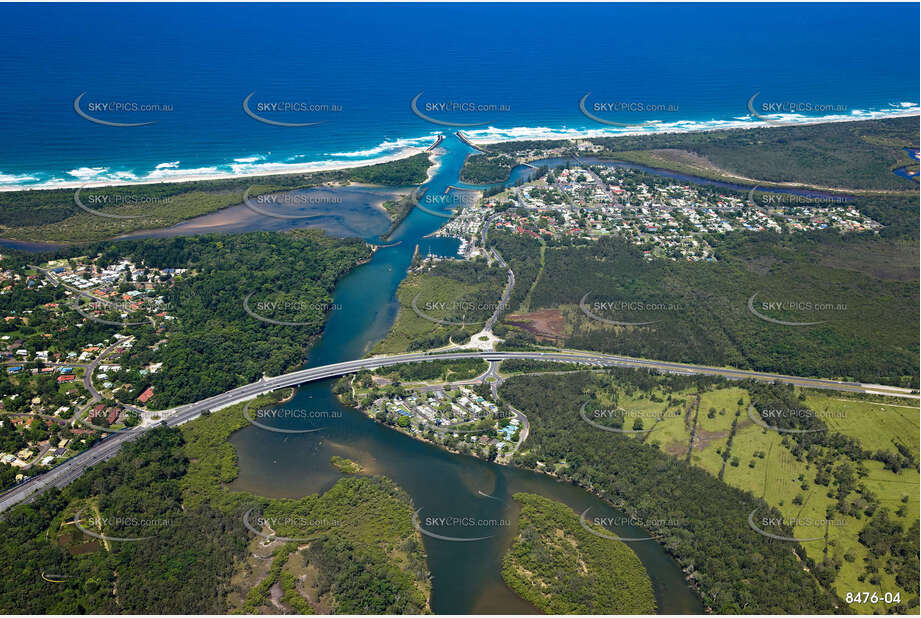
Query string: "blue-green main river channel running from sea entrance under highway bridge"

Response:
xmin=230 ymin=136 xmax=703 ymax=614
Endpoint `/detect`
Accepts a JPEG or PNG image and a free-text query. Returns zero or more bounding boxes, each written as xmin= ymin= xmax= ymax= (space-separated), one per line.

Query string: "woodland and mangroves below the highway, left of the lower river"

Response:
xmin=0 ymin=390 xmax=428 ymax=614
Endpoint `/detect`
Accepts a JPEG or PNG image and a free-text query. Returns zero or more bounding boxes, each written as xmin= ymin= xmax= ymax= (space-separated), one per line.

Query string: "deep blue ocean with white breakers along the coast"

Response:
xmin=0 ymin=3 xmax=921 ymax=187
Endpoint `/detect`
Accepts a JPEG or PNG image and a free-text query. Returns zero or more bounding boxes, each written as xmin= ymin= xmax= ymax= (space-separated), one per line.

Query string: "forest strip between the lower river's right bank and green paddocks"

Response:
xmin=500 ymin=373 xmax=842 ymax=614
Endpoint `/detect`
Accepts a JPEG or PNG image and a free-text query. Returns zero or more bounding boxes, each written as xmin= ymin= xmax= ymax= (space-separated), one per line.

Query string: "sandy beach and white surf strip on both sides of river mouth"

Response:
xmin=0 ymin=107 xmax=921 ymax=193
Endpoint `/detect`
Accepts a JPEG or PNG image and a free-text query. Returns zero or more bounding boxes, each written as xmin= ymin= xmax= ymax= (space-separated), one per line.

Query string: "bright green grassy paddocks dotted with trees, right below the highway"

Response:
xmin=640 ymin=388 xmax=921 ymax=613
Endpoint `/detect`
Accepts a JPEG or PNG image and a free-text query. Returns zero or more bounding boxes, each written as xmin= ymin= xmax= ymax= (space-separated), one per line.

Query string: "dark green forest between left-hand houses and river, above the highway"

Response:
xmin=125 ymin=230 xmax=370 ymax=408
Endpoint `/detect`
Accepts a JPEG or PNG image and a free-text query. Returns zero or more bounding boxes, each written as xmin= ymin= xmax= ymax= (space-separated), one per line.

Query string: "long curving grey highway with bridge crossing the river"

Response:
xmin=0 ymin=350 xmax=918 ymax=512
